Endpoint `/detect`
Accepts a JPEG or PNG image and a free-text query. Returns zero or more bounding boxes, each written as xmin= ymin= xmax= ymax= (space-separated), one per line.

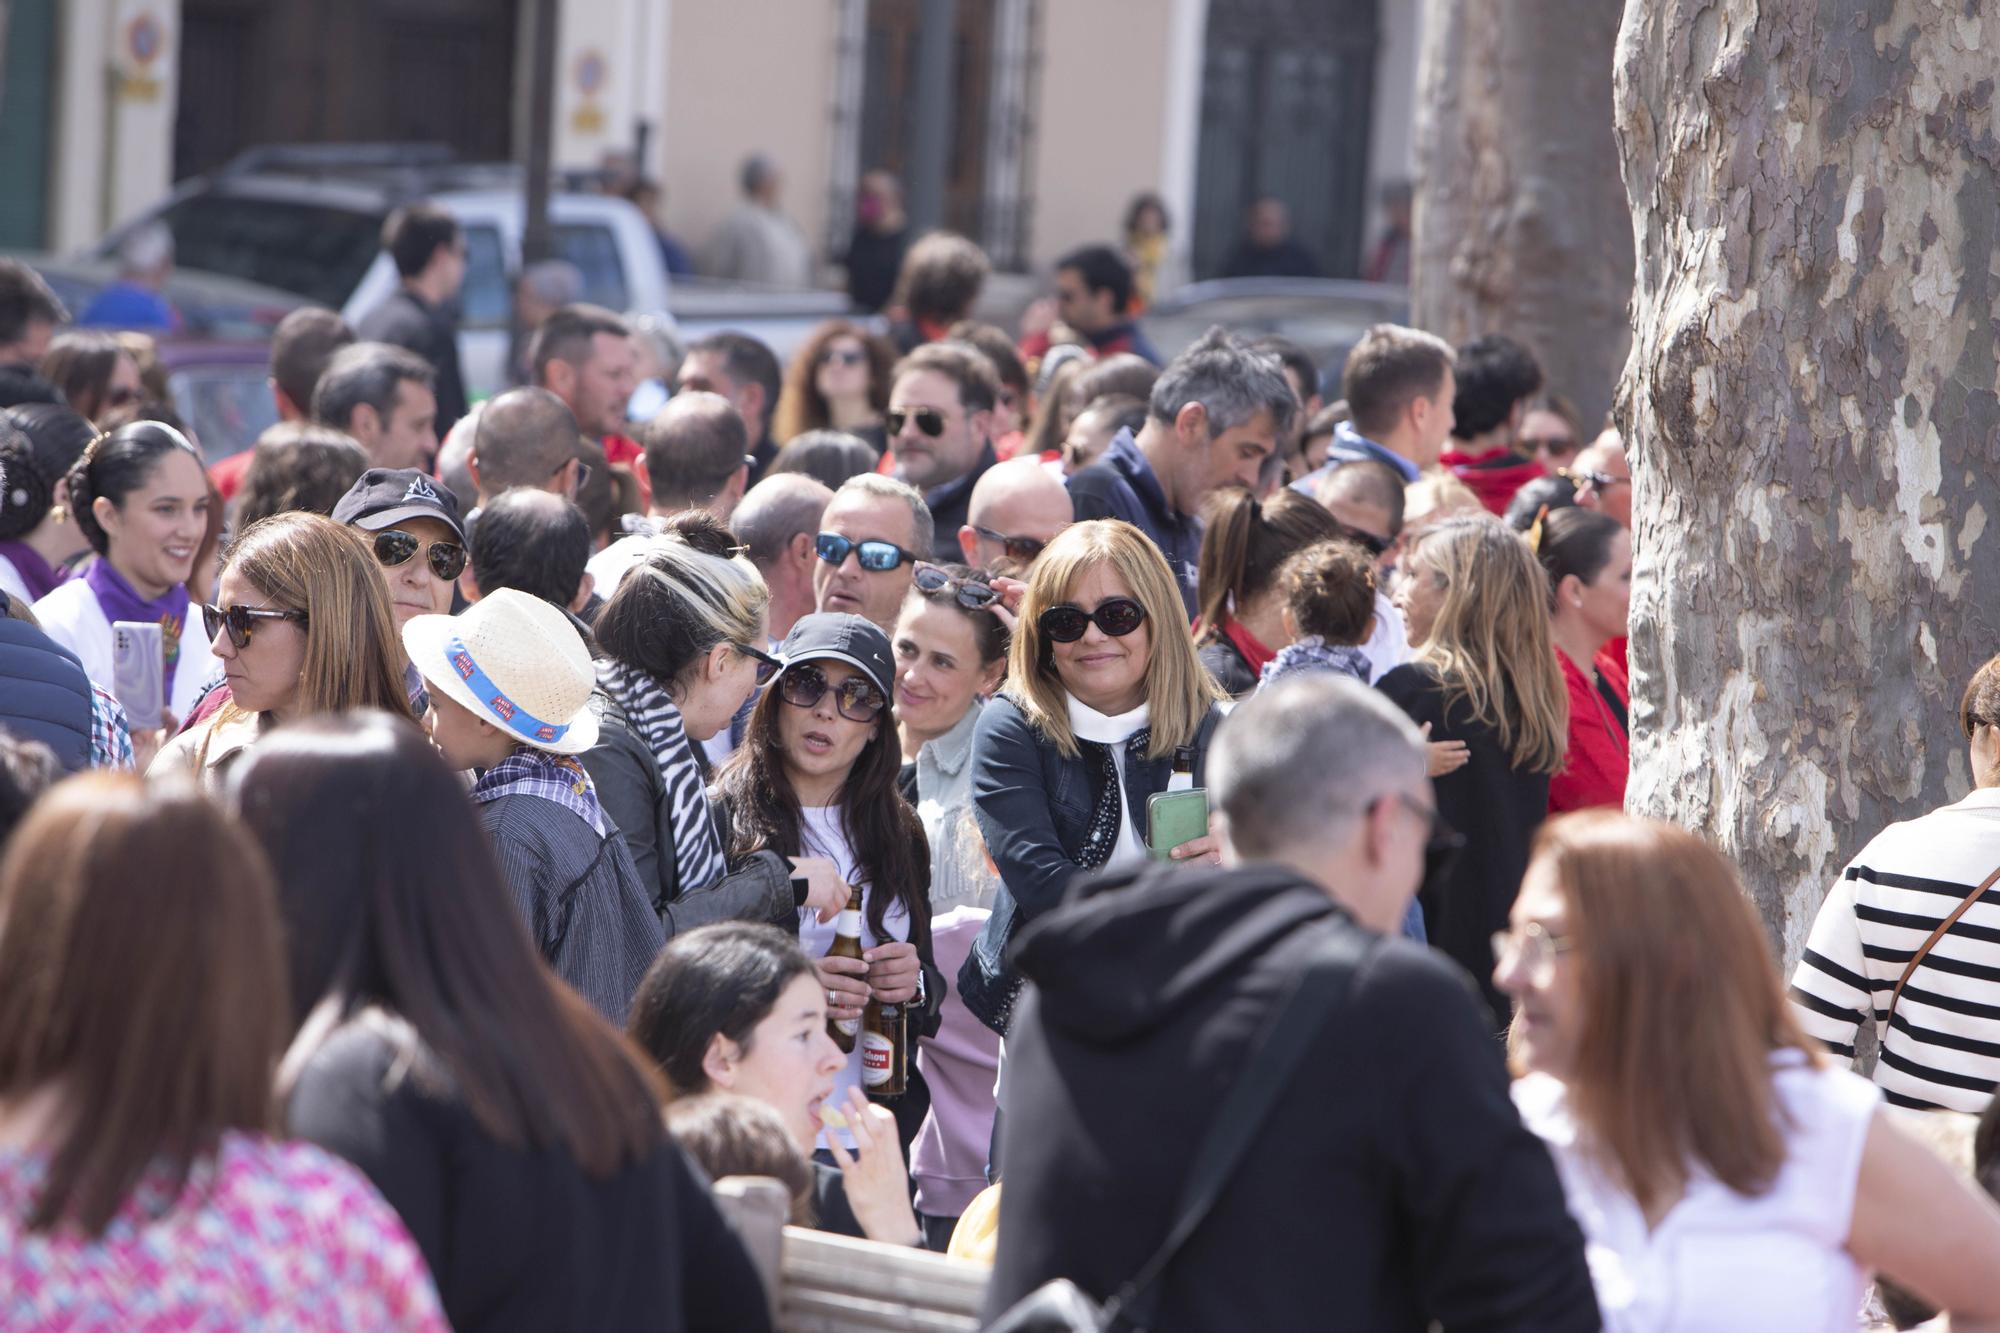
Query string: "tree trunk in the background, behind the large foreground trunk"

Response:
xmin=1410 ymin=0 xmax=1632 ymax=428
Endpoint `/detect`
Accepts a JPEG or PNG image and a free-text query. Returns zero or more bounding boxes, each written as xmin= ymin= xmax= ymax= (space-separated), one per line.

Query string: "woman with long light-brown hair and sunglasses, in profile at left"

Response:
xmin=148 ymin=512 xmax=416 ymax=787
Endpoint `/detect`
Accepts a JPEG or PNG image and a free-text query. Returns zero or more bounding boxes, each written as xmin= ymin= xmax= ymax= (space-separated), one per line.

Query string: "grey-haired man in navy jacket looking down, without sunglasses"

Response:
xmin=1070 ymin=326 xmax=1298 ymax=616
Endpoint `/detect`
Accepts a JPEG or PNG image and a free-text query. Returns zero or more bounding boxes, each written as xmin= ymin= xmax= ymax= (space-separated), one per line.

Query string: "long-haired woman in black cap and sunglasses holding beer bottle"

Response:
xmin=716 ymin=612 xmax=942 ymax=1147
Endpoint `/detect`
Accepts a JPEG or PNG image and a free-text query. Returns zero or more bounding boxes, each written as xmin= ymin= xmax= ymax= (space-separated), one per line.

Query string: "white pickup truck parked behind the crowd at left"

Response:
xmin=94 ymin=144 xmax=850 ymax=398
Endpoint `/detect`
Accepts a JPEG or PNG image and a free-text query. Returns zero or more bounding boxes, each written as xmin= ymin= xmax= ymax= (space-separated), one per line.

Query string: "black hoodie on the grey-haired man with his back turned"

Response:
xmin=990 ymin=867 xmax=1598 ymax=1333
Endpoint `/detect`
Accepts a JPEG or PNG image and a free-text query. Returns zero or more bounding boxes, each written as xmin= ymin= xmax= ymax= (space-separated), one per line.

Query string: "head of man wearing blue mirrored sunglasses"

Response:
xmin=812 ymin=472 xmax=936 ymax=634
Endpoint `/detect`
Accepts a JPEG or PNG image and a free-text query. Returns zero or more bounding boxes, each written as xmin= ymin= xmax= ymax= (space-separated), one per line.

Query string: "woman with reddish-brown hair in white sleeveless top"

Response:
xmin=1494 ymin=811 xmax=2000 ymax=1333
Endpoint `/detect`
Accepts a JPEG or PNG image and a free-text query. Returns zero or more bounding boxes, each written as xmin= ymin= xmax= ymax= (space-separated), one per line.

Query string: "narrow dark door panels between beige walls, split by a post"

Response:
xmin=862 ymin=0 xmax=994 ymax=240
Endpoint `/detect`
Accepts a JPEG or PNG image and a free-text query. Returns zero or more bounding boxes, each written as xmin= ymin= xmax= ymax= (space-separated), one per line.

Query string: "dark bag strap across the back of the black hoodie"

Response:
xmin=1104 ymin=921 xmax=1380 ymax=1329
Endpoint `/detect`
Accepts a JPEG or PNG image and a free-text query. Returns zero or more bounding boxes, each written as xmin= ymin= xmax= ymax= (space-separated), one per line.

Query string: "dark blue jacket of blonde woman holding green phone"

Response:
xmin=958 ymin=695 xmax=1222 ymax=1033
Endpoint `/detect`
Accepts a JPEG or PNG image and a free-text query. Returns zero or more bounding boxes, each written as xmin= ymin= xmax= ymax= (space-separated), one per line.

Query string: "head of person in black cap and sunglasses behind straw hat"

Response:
xmin=334 ymin=468 xmax=466 ymax=628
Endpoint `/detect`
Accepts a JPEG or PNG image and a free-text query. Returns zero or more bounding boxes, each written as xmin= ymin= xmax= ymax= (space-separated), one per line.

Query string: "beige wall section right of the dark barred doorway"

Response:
xmin=1028 ymin=0 xmax=1174 ymax=268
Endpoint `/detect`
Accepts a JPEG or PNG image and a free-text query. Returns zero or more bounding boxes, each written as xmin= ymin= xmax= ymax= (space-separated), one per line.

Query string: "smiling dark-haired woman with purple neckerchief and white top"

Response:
xmin=34 ymin=420 xmax=216 ymax=733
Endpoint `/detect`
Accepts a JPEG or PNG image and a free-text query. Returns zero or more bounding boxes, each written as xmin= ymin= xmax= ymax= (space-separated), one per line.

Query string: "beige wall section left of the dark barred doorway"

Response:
xmin=660 ymin=0 xmax=838 ymax=272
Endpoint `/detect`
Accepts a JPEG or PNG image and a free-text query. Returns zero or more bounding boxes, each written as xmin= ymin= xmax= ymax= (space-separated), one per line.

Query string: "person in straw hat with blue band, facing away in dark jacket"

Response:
xmin=402 ymin=588 xmax=666 ymax=1025
